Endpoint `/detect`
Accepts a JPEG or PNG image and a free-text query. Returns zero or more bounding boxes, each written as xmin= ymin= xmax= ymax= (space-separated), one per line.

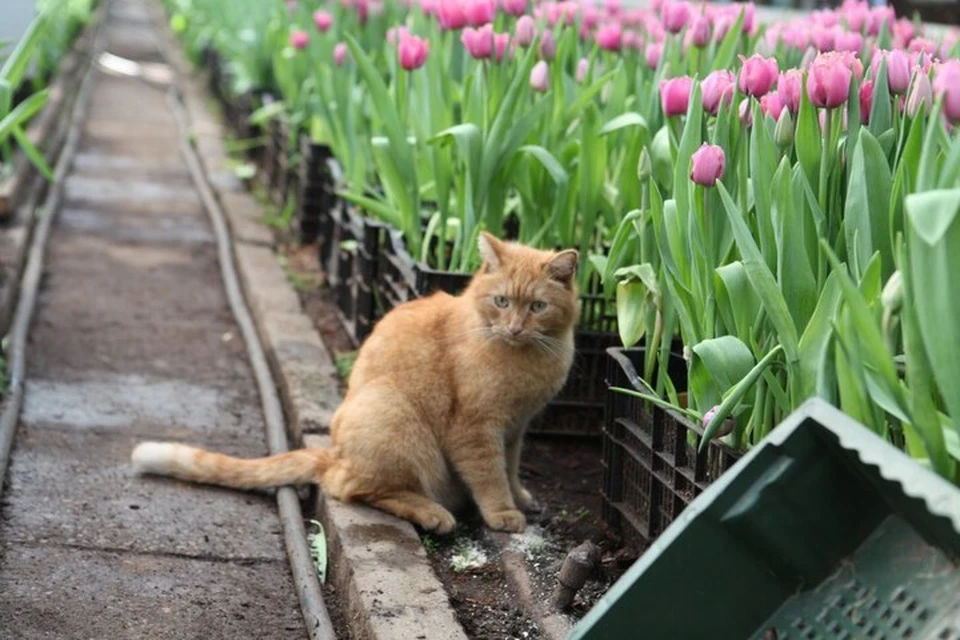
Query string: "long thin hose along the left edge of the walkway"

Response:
xmin=0 ymin=25 xmax=102 ymax=502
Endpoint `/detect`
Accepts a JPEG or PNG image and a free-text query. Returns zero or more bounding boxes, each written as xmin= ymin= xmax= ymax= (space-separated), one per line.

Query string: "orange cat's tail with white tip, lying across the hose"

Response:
xmin=131 ymin=442 xmax=335 ymax=489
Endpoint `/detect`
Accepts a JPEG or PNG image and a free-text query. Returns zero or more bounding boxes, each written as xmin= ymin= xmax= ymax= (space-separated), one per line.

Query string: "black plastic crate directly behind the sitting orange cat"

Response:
xmin=375 ymin=230 xmax=620 ymax=437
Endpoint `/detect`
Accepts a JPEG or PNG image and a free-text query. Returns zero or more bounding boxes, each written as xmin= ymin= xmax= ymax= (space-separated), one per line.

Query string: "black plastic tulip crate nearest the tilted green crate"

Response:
xmin=602 ymin=345 xmax=741 ymax=547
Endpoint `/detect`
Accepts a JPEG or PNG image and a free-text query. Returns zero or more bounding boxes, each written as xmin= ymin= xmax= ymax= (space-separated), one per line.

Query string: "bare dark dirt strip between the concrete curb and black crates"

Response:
xmin=281 ymin=241 xmax=640 ymax=640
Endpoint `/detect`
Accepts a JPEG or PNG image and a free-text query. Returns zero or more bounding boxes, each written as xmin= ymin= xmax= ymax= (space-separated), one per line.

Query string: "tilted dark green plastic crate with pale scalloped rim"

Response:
xmin=569 ymin=400 xmax=960 ymax=640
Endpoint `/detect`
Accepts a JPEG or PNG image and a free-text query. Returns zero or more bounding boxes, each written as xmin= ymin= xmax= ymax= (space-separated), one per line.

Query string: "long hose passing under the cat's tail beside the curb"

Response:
xmin=167 ymin=88 xmax=336 ymax=640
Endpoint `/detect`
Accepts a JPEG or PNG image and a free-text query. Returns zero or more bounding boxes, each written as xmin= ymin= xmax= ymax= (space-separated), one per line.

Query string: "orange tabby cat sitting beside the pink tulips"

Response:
xmin=133 ymin=233 xmax=578 ymax=533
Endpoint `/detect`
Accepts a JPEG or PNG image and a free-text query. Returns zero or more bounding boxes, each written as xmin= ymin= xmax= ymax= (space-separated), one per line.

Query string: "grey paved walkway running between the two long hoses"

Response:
xmin=0 ymin=0 xmax=306 ymax=640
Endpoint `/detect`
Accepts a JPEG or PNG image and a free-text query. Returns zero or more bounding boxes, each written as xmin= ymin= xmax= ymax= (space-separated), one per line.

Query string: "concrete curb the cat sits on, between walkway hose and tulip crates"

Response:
xmin=157 ymin=11 xmax=467 ymax=640
